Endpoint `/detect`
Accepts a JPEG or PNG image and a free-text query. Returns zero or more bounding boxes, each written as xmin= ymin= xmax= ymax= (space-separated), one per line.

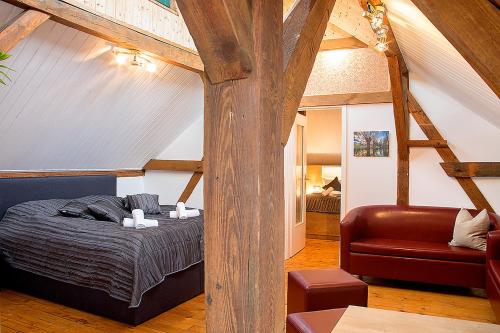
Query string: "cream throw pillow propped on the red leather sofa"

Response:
xmin=449 ymin=208 xmax=490 ymax=251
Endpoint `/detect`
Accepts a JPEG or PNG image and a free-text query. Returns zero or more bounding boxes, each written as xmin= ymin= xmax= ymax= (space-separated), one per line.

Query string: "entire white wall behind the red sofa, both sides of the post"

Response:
xmin=342 ymin=74 xmax=500 ymax=212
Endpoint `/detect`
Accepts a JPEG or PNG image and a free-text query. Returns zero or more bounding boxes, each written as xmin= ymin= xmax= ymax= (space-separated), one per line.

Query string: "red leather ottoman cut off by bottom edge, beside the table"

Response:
xmin=286 ymin=309 xmax=346 ymax=333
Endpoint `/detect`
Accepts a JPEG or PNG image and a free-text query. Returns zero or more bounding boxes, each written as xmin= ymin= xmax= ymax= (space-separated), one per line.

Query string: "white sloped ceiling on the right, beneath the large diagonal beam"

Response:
xmin=384 ymin=0 xmax=500 ymax=128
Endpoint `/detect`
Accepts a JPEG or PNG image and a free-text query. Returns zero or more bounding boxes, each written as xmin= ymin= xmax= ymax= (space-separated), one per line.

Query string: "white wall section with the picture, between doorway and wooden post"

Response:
xmin=342 ymin=103 xmax=397 ymax=212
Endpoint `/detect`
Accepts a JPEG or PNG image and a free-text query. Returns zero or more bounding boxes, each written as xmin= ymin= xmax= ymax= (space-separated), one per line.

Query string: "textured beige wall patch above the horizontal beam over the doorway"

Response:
xmin=304 ymin=48 xmax=391 ymax=96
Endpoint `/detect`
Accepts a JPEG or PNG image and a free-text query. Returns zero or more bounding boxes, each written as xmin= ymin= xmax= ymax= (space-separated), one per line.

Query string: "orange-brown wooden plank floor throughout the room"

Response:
xmin=0 ymin=239 xmax=494 ymax=333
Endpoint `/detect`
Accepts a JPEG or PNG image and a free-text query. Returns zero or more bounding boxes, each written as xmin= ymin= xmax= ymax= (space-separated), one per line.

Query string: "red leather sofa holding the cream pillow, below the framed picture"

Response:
xmin=340 ymin=206 xmax=500 ymax=288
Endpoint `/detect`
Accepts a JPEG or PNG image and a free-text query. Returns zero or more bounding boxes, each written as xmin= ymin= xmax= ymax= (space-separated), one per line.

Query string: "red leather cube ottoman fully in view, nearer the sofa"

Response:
xmin=287 ymin=268 xmax=368 ymax=314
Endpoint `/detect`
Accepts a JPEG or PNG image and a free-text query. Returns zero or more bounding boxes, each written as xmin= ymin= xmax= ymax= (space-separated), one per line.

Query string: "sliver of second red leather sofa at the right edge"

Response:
xmin=486 ymin=231 xmax=500 ymax=323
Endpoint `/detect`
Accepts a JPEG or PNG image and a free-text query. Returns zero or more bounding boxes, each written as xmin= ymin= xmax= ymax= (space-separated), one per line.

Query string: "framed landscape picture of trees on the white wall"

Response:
xmin=354 ymin=131 xmax=389 ymax=157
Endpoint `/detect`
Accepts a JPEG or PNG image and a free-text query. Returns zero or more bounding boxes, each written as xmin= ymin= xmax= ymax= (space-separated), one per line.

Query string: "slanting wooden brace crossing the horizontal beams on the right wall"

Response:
xmin=408 ymin=94 xmax=494 ymax=212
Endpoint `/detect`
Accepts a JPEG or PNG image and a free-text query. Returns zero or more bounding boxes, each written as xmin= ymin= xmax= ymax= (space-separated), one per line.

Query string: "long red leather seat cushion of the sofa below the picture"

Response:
xmin=351 ymin=238 xmax=486 ymax=264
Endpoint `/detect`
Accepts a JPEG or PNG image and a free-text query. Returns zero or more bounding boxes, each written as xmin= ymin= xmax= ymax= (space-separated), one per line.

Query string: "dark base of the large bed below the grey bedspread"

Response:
xmin=0 ymin=262 xmax=204 ymax=325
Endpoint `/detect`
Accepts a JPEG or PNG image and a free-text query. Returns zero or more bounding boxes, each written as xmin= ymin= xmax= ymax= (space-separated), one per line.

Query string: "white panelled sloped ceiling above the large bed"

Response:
xmin=0 ymin=2 xmax=203 ymax=170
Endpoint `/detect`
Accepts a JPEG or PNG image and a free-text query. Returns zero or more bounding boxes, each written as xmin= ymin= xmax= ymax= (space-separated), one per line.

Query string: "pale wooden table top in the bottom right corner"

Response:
xmin=332 ymin=306 xmax=500 ymax=333
